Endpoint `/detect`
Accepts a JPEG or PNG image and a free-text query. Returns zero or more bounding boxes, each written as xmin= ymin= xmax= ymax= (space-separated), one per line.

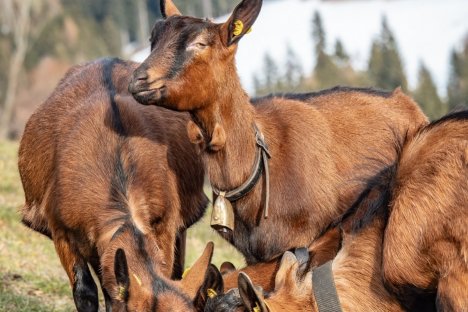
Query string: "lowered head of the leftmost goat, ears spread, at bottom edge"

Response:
xmin=109 ymin=243 xmax=219 ymax=312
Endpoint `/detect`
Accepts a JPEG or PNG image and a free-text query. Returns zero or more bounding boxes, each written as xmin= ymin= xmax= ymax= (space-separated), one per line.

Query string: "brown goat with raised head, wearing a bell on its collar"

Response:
xmin=129 ymin=0 xmax=427 ymax=264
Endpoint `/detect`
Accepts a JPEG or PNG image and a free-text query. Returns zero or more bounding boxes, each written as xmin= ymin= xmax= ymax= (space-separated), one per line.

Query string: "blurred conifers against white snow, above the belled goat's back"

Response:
xmin=254 ymin=12 xmax=458 ymax=119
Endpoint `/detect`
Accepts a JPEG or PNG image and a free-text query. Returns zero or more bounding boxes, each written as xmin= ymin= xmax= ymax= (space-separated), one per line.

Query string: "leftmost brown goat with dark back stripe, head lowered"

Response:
xmin=18 ymin=59 xmax=207 ymax=311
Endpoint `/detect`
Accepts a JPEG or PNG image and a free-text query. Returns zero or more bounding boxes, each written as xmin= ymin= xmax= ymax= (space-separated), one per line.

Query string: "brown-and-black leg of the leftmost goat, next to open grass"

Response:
xmin=53 ymin=233 xmax=99 ymax=312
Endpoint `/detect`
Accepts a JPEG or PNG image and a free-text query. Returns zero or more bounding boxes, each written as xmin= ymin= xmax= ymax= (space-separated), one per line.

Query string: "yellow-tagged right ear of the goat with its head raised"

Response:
xmin=221 ymin=0 xmax=263 ymax=46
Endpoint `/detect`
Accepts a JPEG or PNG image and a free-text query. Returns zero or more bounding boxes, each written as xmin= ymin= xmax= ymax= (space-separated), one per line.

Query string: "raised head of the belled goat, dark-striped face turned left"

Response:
xmin=129 ymin=0 xmax=262 ymax=111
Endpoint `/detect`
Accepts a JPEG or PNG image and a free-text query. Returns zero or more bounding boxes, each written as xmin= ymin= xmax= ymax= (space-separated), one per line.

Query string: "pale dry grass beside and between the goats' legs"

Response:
xmin=0 ymin=141 xmax=243 ymax=312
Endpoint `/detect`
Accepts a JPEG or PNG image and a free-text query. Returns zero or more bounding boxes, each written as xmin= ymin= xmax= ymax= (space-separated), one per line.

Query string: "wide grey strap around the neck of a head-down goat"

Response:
xmin=312 ymin=261 xmax=342 ymax=312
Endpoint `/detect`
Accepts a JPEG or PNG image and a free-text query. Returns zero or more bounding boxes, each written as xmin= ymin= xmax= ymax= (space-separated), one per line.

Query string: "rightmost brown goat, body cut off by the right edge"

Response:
xmin=383 ymin=111 xmax=468 ymax=311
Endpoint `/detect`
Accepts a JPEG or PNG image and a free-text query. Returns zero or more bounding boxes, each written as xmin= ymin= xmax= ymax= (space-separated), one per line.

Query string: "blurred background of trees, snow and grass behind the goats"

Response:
xmin=0 ymin=0 xmax=468 ymax=311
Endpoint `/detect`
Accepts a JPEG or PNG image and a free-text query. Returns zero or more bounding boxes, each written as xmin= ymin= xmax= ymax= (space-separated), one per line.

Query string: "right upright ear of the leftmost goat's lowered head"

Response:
xmin=180 ymin=242 xmax=214 ymax=300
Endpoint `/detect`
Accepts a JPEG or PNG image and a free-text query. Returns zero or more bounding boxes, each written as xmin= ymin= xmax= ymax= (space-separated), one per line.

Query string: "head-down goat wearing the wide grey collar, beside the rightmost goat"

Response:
xmin=237 ymin=167 xmax=404 ymax=312
